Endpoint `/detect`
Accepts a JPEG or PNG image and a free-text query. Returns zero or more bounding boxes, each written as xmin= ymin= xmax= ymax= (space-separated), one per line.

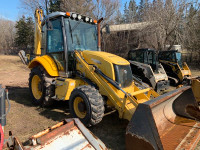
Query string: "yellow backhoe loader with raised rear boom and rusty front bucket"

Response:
xmin=19 ymin=9 xmax=200 ymax=149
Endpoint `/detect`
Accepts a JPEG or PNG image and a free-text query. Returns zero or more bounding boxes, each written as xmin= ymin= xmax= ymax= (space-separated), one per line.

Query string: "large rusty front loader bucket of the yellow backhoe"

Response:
xmin=126 ymin=86 xmax=200 ymax=150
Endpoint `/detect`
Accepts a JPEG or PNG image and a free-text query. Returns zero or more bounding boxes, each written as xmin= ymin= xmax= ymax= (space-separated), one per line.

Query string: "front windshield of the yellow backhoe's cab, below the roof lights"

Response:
xmin=65 ymin=18 xmax=97 ymax=51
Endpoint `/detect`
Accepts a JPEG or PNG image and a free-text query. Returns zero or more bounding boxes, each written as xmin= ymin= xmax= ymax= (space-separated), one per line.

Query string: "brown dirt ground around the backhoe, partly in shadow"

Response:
xmin=0 ymin=55 xmax=200 ymax=150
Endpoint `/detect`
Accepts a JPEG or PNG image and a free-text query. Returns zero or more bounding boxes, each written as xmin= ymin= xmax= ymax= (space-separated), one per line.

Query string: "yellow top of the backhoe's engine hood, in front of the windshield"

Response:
xmin=83 ymin=51 xmax=130 ymax=65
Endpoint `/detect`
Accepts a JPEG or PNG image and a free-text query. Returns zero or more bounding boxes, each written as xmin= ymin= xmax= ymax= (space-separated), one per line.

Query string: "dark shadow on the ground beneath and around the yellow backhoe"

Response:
xmin=6 ymin=86 xmax=128 ymax=150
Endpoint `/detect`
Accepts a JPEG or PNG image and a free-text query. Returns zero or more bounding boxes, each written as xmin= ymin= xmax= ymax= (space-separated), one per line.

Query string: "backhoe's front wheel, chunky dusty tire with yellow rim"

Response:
xmin=69 ymin=85 xmax=105 ymax=126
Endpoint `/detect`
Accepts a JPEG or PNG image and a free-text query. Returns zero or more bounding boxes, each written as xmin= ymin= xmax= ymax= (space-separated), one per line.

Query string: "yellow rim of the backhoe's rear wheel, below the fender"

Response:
xmin=31 ymin=75 xmax=42 ymax=100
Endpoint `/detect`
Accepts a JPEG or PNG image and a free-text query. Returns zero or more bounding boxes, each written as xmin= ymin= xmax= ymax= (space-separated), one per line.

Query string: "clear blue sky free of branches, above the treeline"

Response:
xmin=0 ymin=0 xmax=138 ymax=21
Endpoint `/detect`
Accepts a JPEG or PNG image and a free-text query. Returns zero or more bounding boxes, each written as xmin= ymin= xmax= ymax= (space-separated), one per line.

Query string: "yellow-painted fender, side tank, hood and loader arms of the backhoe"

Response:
xmin=29 ymin=51 xmax=159 ymax=120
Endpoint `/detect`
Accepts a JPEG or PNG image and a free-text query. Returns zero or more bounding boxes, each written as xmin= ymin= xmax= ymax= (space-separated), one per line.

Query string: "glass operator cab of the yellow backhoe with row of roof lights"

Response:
xmin=41 ymin=12 xmax=98 ymax=76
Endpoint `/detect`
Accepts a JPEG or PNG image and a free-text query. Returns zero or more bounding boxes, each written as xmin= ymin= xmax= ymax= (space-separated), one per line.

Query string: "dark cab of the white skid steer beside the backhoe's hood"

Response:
xmin=128 ymin=49 xmax=157 ymax=70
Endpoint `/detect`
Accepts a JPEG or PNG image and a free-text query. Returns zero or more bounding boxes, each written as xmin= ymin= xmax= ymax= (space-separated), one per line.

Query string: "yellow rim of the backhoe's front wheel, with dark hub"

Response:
xmin=74 ymin=97 xmax=86 ymax=119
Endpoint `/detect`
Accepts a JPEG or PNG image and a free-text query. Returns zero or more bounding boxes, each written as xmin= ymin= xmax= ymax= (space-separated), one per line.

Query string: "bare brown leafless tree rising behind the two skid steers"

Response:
xmin=140 ymin=0 xmax=186 ymax=50
